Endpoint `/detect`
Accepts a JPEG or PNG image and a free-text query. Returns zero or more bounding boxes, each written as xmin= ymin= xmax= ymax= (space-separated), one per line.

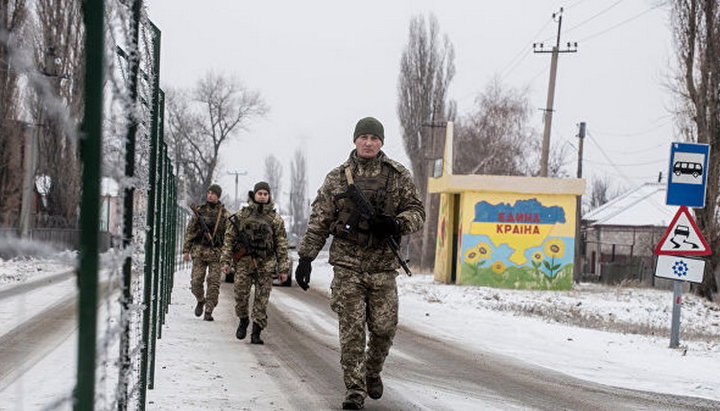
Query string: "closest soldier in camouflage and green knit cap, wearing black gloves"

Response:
xmin=295 ymin=117 xmax=425 ymax=409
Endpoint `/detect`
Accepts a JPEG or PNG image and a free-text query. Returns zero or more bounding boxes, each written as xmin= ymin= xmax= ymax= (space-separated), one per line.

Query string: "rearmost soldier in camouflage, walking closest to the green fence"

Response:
xmin=183 ymin=184 xmax=230 ymax=321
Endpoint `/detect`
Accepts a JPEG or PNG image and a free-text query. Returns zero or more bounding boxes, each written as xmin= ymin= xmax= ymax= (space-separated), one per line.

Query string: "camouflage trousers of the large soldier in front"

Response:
xmin=330 ymin=266 xmax=398 ymax=396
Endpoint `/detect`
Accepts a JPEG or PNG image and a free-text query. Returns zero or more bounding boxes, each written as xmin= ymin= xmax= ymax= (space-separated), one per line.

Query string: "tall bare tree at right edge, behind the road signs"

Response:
xmin=671 ymin=0 xmax=720 ymax=300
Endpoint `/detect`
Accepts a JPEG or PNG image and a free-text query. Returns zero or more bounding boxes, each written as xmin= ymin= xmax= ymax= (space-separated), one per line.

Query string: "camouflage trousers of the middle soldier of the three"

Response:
xmin=234 ymin=259 xmax=272 ymax=329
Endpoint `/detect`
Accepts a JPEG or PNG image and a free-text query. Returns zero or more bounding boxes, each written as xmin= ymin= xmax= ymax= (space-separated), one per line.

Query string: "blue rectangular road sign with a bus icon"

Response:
xmin=665 ymin=143 xmax=710 ymax=208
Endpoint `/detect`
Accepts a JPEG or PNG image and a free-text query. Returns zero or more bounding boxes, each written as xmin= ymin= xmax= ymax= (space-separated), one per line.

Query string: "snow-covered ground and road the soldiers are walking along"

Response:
xmin=0 ymin=258 xmax=720 ymax=411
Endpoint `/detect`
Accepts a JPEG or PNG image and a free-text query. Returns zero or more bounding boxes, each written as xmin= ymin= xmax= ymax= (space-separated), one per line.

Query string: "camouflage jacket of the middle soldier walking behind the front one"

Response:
xmin=220 ymin=199 xmax=290 ymax=273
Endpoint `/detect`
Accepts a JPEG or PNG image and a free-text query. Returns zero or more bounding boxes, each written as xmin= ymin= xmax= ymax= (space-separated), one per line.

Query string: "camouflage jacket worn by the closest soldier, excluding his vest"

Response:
xmin=298 ymin=150 xmax=425 ymax=273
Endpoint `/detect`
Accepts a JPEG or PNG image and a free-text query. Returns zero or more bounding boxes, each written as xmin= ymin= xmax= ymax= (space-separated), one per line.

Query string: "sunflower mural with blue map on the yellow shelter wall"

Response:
xmin=458 ymin=193 xmax=575 ymax=290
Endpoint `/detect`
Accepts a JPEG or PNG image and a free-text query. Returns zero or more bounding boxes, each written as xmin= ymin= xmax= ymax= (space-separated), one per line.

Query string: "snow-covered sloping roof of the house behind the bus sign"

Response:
xmin=583 ymin=183 xmax=677 ymax=227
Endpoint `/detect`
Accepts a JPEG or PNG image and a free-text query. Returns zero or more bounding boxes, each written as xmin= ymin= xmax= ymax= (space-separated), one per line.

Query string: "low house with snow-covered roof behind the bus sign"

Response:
xmin=580 ymin=183 xmax=678 ymax=286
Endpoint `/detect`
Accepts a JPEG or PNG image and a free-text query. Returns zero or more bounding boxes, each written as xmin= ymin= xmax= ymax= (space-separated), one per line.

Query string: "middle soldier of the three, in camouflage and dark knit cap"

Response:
xmin=221 ymin=181 xmax=290 ymax=344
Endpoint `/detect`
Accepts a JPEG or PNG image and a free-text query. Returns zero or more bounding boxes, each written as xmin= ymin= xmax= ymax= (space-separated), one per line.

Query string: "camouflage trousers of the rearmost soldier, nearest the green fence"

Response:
xmin=190 ymin=247 xmax=221 ymax=313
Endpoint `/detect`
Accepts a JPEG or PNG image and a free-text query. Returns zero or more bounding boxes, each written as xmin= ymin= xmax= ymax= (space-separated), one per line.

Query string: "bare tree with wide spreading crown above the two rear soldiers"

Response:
xmin=166 ymin=72 xmax=268 ymax=204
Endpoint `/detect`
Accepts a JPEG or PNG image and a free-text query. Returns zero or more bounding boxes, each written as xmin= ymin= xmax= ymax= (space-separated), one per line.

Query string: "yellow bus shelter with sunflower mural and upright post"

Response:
xmin=428 ymin=123 xmax=585 ymax=289
